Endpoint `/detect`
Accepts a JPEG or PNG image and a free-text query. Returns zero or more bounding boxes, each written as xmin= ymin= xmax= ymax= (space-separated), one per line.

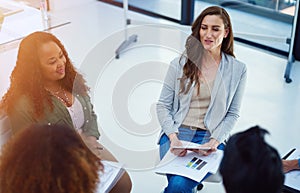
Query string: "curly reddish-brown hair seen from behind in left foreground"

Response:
xmin=0 ymin=125 xmax=103 ymax=193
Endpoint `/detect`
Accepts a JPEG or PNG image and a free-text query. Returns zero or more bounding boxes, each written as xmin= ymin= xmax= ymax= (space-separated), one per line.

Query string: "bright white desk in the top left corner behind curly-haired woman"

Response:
xmin=0 ymin=0 xmax=70 ymax=52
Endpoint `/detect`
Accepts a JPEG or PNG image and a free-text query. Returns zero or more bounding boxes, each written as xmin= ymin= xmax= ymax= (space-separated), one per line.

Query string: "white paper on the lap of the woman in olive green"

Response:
xmin=96 ymin=161 xmax=125 ymax=193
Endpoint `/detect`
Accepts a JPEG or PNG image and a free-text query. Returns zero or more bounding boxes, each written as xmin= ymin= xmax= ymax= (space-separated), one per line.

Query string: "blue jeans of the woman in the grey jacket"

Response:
xmin=159 ymin=127 xmax=225 ymax=193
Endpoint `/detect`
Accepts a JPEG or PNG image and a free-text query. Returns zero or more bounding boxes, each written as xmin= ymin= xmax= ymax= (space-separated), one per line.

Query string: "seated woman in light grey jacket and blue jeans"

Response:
xmin=157 ymin=6 xmax=246 ymax=193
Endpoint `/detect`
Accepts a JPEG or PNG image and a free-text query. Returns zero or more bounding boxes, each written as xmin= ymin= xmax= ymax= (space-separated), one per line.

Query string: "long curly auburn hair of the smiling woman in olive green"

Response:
xmin=0 ymin=32 xmax=89 ymax=119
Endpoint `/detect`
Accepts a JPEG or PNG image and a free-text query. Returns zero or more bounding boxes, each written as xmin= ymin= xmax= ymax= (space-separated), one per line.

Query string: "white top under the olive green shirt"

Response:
xmin=67 ymin=97 xmax=84 ymax=129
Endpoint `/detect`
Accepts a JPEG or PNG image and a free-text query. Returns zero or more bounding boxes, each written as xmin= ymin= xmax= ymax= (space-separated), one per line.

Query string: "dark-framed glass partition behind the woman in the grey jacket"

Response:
xmin=100 ymin=0 xmax=296 ymax=56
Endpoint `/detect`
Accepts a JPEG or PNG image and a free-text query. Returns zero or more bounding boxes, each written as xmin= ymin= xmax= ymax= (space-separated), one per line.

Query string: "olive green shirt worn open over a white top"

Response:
xmin=9 ymin=94 xmax=100 ymax=139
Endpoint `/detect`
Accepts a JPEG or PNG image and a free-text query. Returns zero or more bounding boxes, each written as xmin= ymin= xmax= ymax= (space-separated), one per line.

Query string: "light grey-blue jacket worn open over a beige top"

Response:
xmin=156 ymin=53 xmax=247 ymax=142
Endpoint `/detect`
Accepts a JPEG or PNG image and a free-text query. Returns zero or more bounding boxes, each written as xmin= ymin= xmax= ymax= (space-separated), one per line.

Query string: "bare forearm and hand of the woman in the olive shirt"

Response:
xmin=78 ymin=129 xmax=104 ymax=159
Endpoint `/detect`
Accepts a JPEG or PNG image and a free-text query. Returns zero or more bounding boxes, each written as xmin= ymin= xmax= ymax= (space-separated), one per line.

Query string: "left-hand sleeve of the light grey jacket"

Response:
xmin=156 ymin=59 xmax=179 ymax=135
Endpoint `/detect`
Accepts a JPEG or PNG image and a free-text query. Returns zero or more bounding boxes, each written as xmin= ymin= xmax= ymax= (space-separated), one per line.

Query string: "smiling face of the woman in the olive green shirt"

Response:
xmin=39 ymin=41 xmax=66 ymax=84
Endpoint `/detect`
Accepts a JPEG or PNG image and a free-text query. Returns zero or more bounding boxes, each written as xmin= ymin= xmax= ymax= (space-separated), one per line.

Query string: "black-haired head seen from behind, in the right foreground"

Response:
xmin=220 ymin=126 xmax=284 ymax=193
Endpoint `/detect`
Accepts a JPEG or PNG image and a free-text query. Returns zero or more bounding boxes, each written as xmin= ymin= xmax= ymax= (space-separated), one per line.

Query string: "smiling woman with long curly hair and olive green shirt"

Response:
xmin=0 ymin=32 xmax=131 ymax=192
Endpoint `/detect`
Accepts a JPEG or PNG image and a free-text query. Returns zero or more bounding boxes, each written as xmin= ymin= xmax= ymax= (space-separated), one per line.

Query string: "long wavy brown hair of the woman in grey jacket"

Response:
xmin=180 ymin=6 xmax=234 ymax=94
